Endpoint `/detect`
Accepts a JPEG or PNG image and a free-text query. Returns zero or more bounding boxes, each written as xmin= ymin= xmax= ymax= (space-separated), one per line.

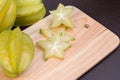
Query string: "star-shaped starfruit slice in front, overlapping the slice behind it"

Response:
xmin=37 ymin=34 xmax=71 ymax=60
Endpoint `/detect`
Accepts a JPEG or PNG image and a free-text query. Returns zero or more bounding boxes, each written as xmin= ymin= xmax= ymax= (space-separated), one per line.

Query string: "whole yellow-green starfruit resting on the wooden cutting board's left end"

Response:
xmin=0 ymin=27 xmax=34 ymax=77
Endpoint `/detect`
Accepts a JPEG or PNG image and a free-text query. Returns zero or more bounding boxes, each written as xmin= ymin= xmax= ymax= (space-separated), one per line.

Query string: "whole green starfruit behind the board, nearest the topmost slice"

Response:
xmin=15 ymin=0 xmax=46 ymax=26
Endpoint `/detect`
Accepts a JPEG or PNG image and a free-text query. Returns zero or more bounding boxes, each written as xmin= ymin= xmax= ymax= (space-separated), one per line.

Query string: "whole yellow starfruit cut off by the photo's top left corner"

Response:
xmin=0 ymin=0 xmax=16 ymax=32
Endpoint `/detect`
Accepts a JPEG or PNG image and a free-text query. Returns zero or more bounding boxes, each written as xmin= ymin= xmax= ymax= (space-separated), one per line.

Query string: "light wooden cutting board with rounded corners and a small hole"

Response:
xmin=0 ymin=6 xmax=120 ymax=80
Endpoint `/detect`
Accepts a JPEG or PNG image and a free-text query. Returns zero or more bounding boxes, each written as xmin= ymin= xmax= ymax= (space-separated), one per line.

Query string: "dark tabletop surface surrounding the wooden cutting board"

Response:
xmin=43 ymin=0 xmax=120 ymax=80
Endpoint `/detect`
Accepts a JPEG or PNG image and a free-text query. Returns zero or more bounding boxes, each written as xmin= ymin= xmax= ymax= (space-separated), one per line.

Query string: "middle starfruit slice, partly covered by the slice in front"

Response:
xmin=40 ymin=28 xmax=75 ymax=41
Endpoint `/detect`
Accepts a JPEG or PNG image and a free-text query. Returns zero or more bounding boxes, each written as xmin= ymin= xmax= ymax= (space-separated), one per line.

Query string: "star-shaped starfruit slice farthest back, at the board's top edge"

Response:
xmin=50 ymin=3 xmax=73 ymax=28
